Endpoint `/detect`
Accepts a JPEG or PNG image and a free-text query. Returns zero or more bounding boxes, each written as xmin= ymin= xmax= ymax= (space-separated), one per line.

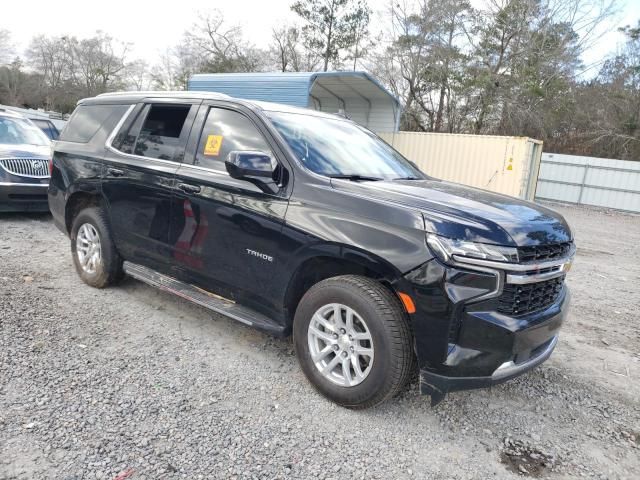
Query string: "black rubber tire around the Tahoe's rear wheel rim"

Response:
xmin=70 ymin=207 xmax=124 ymax=288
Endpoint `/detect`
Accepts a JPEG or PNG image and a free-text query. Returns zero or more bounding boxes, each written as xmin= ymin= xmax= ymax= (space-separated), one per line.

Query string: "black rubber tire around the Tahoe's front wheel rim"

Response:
xmin=293 ymin=275 xmax=414 ymax=409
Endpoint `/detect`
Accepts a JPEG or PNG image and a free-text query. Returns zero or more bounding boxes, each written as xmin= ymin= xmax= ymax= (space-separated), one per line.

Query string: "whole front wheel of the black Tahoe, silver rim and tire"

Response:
xmin=293 ymin=275 xmax=413 ymax=409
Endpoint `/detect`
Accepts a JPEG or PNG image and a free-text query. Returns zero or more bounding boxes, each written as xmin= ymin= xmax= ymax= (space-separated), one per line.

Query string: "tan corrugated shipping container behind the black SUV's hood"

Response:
xmin=379 ymin=132 xmax=542 ymax=200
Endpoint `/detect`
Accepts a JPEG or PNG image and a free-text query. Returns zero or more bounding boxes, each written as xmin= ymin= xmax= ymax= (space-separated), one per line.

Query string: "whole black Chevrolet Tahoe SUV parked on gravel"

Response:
xmin=49 ymin=92 xmax=575 ymax=408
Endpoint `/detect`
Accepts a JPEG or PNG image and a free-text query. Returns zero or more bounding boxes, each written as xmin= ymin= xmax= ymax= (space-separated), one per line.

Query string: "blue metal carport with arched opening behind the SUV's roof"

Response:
xmin=188 ymin=72 xmax=400 ymax=132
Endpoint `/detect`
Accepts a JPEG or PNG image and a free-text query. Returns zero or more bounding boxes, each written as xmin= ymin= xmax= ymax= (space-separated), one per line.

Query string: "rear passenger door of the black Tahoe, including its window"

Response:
xmin=102 ymin=99 xmax=200 ymax=271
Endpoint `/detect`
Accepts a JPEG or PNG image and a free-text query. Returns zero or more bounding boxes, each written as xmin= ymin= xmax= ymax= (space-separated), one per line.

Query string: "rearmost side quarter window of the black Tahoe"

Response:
xmin=60 ymin=105 xmax=128 ymax=143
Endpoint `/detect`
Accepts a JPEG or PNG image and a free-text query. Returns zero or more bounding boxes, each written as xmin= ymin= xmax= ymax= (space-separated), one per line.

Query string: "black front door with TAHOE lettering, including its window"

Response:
xmin=169 ymin=103 xmax=288 ymax=314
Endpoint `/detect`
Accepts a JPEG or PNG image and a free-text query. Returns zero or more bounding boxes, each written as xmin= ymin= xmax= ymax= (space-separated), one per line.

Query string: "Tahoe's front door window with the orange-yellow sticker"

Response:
xmin=195 ymin=107 xmax=273 ymax=171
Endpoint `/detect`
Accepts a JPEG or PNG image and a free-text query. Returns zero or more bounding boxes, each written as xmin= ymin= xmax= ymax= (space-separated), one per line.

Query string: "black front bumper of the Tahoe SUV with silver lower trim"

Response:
xmin=398 ymin=255 xmax=569 ymax=404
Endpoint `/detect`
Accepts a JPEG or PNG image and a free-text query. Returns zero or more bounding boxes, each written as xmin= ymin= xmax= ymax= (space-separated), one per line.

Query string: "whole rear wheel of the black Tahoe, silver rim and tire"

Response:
xmin=71 ymin=207 xmax=123 ymax=288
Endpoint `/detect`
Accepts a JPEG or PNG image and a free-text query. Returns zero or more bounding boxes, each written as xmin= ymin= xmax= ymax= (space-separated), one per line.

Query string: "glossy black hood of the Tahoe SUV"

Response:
xmin=332 ymin=179 xmax=572 ymax=246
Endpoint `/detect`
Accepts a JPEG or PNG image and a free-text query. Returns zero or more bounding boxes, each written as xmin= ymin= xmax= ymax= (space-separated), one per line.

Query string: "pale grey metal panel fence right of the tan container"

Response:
xmin=536 ymin=153 xmax=640 ymax=212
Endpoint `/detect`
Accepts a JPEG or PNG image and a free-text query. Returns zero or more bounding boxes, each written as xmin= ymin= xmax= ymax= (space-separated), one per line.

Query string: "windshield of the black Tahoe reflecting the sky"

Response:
xmin=267 ymin=112 xmax=426 ymax=180
